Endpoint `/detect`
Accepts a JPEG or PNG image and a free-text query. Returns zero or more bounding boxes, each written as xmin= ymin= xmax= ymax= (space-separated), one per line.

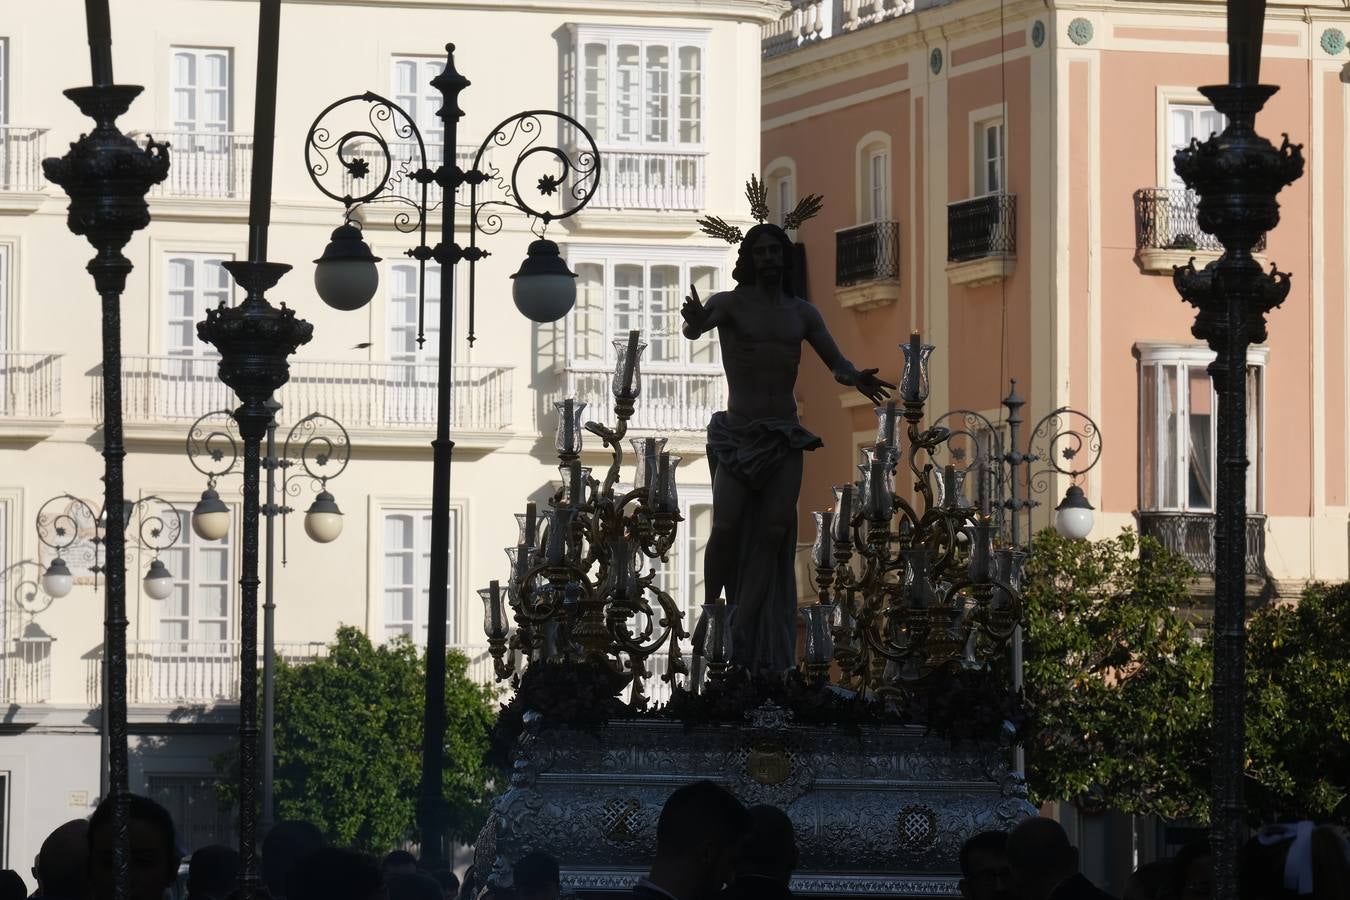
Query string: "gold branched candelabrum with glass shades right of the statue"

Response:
xmin=802 ymin=333 xmax=1026 ymax=698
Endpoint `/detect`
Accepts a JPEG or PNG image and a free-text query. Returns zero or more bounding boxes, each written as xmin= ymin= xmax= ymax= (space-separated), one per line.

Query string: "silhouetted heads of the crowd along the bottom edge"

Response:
xmin=0 ymin=781 xmax=1350 ymax=900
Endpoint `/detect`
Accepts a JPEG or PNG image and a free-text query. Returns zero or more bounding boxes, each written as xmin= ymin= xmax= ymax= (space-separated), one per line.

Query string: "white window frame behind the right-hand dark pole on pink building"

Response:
xmin=1134 ymin=343 xmax=1270 ymax=514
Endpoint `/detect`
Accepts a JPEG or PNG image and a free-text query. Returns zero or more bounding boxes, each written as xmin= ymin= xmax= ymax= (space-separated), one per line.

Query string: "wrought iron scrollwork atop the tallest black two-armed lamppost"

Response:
xmin=305 ymin=92 xmax=599 ymax=347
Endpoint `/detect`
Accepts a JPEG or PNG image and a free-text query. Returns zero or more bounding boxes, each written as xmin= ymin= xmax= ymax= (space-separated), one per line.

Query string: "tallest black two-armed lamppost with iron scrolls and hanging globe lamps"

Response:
xmin=305 ymin=43 xmax=599 ymax=869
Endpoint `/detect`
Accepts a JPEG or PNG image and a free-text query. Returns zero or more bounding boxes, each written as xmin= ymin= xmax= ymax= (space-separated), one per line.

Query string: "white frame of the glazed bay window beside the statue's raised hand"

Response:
xmin=563 ymin=244 xmax=734 ymax=372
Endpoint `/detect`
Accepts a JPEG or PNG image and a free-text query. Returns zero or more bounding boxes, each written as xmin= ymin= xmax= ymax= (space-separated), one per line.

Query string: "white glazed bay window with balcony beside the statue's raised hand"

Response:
xmin=564 ymin=244 xmax=729 ymax=430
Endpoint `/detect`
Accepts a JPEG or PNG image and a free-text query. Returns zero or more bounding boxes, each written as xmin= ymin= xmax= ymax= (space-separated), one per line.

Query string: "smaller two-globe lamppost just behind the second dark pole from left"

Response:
xmin=188 ymin=401 xmax=351 ymax=834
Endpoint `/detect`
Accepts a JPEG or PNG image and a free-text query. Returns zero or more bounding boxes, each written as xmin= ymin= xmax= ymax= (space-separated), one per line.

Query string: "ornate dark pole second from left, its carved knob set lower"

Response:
xmin=197 ymin=0 xmax=313 ymax=900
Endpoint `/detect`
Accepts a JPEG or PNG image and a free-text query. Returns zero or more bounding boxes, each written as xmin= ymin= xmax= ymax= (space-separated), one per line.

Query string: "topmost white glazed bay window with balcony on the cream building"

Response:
xmin=570 ymin=26 xmax=707 ymax=210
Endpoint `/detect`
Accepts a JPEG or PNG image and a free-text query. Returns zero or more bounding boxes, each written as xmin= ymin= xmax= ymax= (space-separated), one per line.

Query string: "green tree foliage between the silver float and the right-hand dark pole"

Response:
xmin=1025 ymin=529 xmax=1211 ymax=820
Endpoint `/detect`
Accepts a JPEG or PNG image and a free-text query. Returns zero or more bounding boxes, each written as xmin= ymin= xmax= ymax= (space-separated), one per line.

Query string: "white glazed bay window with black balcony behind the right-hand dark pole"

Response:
xmin=1137 ymin=344 xmax=1268 ymax=573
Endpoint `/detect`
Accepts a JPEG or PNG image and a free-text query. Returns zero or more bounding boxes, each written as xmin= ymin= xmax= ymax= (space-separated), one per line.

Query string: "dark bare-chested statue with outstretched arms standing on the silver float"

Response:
xmin=682 ymin=225 xmax=888 ymax=671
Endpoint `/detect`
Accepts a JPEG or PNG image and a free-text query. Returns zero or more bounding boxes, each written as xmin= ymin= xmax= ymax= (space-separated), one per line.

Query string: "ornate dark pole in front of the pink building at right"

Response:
xmin=1173 ymin=0 xmax=1303 ymax=900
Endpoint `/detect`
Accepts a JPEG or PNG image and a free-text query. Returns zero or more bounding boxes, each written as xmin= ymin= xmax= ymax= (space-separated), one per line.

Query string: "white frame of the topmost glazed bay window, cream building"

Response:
xmin=564 ymin=23 xmax=711 ymax=150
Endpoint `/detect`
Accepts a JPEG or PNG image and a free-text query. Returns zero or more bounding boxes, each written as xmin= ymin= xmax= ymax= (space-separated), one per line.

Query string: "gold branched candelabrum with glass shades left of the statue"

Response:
xmin=478 ymin=331 xmax=689 ymax=704
